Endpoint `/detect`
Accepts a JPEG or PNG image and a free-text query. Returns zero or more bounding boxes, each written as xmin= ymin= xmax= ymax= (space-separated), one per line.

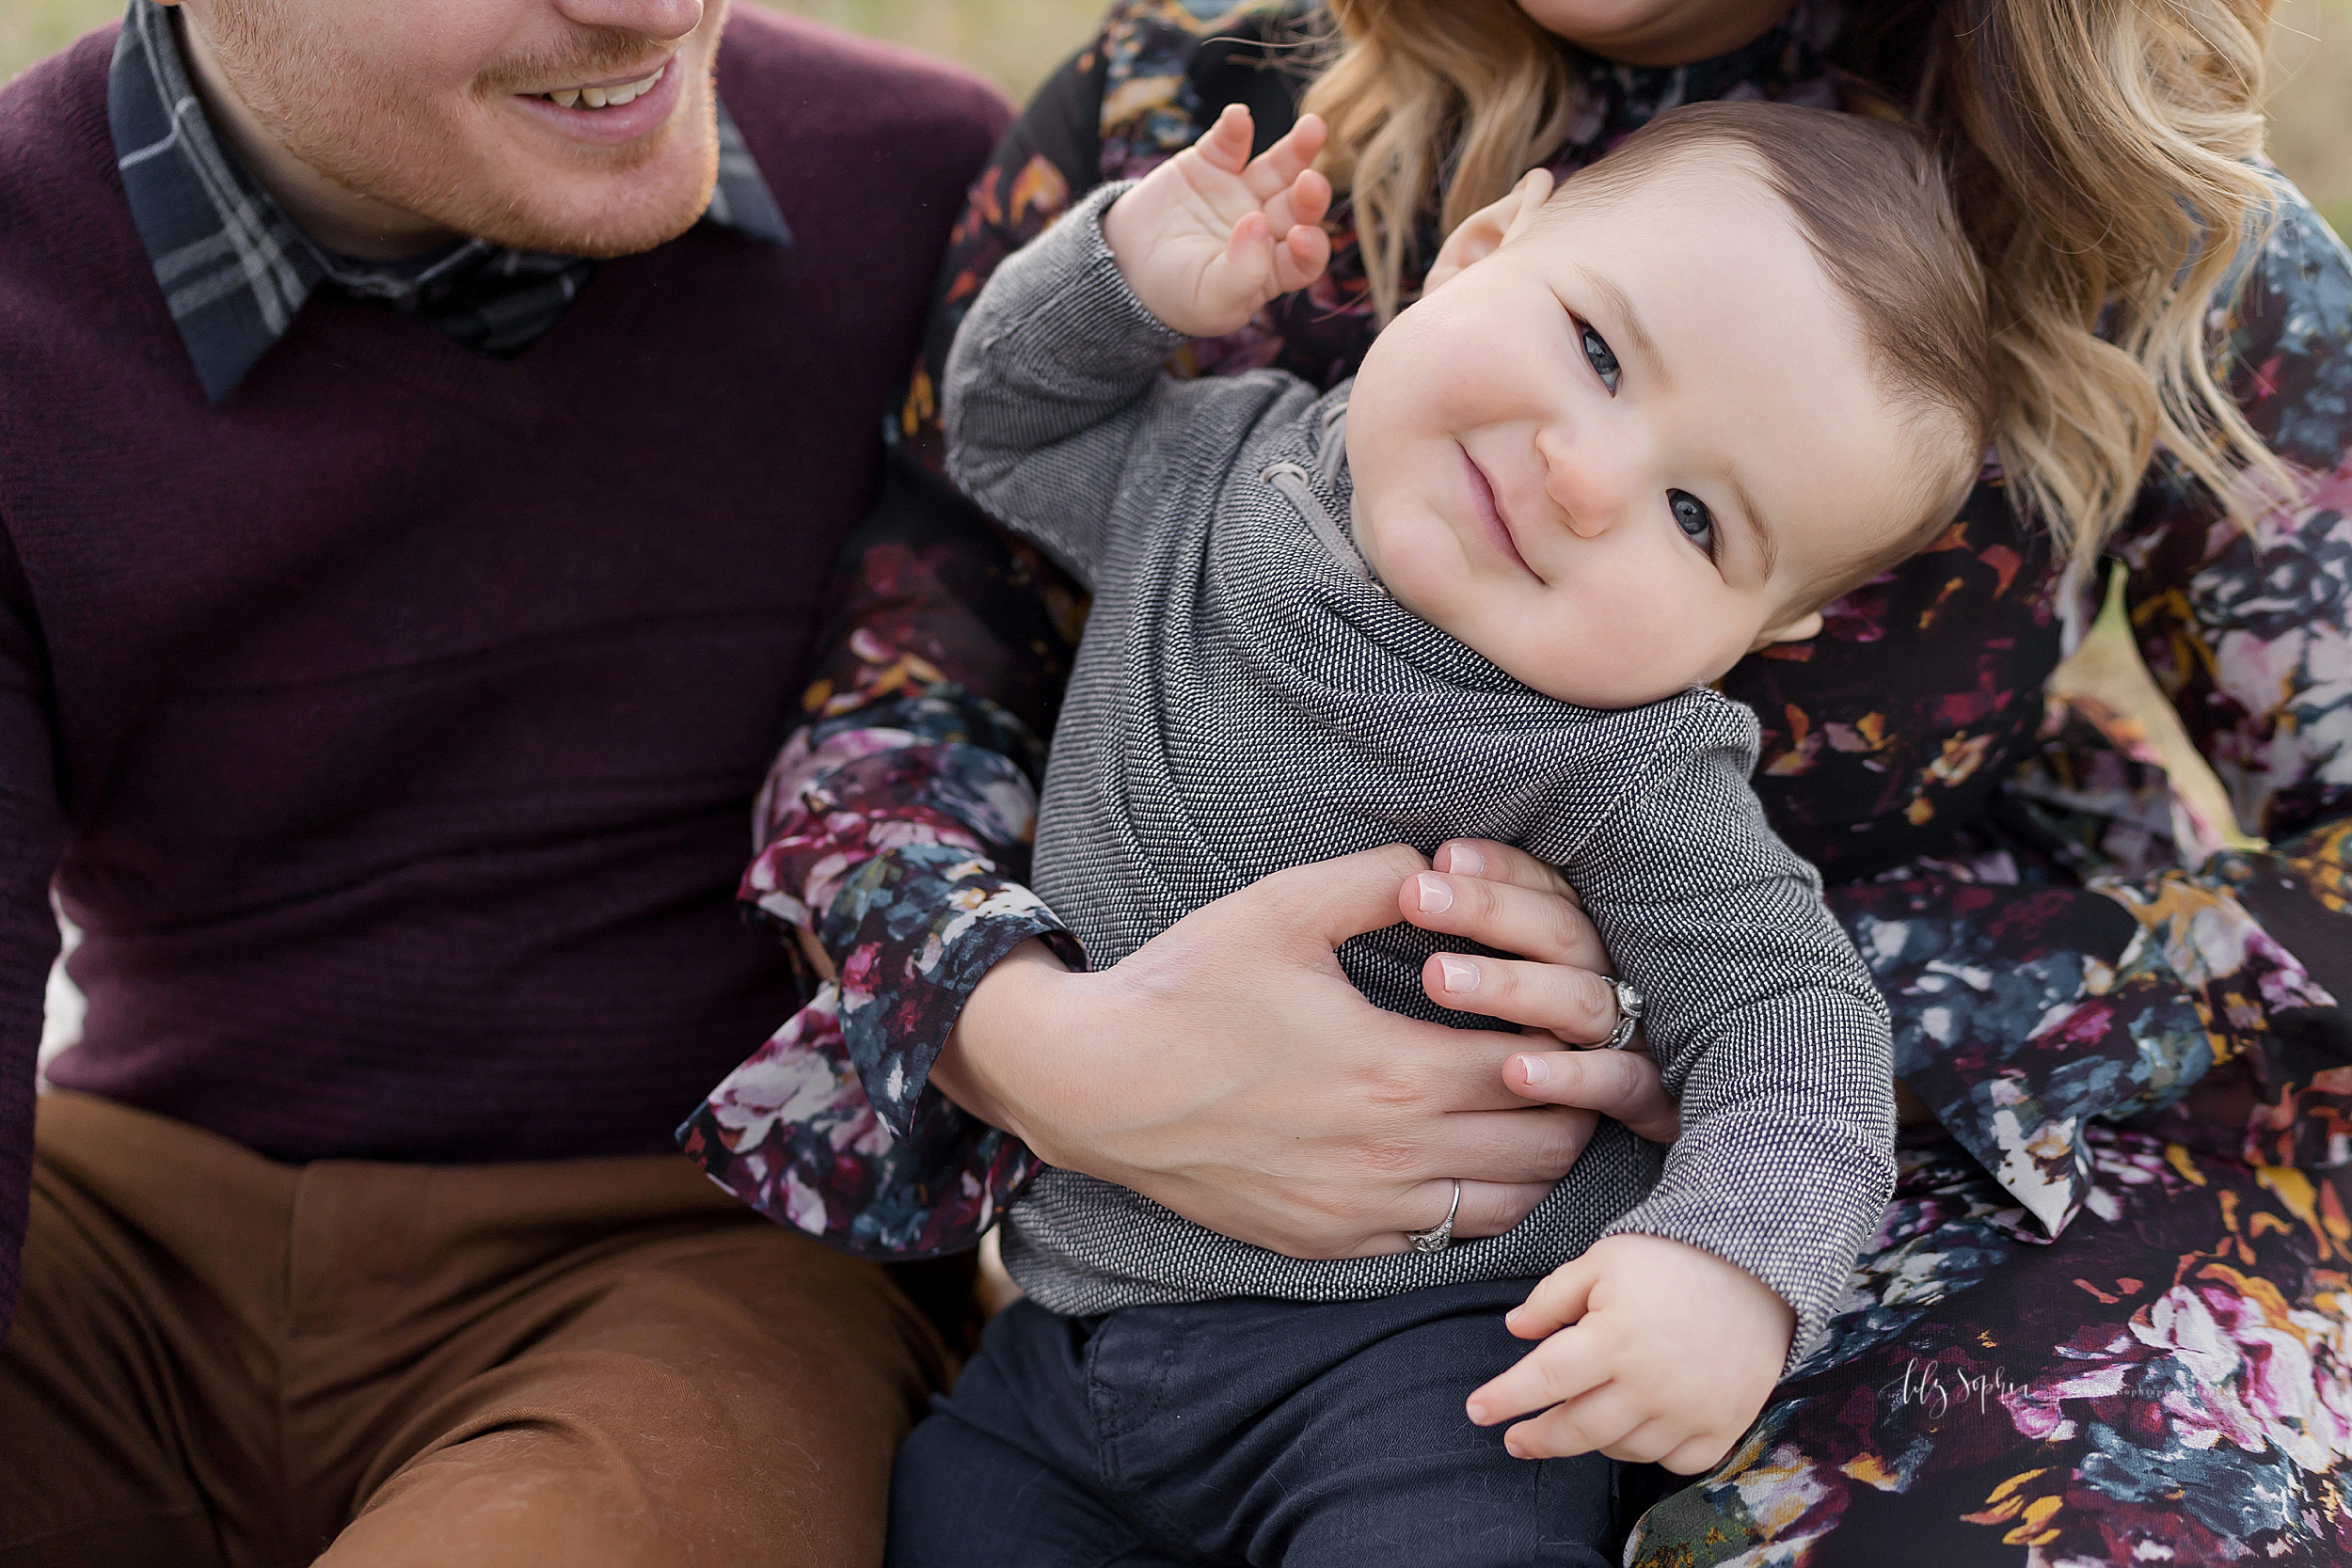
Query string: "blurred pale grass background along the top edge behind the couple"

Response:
xmin=0 ymin=0 xmax=2352 ymax=235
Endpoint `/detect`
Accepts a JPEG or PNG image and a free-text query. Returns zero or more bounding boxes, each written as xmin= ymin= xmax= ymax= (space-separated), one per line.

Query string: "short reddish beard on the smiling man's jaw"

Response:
xmin=199 ymin=0 xmax=724 ymax=256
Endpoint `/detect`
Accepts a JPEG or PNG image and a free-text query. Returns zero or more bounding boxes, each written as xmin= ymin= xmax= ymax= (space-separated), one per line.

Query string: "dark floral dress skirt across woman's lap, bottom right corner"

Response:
xmin=1626 ymin=1126 xmax=2352 ymax=1568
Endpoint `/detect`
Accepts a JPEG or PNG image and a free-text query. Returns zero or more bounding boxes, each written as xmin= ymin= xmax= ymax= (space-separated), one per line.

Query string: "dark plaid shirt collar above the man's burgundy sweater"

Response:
xmin=106 ymin=0 xmax=793 ymax=402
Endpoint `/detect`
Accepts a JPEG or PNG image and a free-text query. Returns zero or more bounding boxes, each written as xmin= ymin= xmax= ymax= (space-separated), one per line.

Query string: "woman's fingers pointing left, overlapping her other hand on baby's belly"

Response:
xmin=1400 ymin=839 xmax=1682 ymax=1143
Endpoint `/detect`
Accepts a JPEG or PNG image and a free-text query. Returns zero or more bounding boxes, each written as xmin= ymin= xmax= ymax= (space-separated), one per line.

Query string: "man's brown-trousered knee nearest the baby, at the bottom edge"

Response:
xmin=323 ymin=1227 xmax=946 ymax=1568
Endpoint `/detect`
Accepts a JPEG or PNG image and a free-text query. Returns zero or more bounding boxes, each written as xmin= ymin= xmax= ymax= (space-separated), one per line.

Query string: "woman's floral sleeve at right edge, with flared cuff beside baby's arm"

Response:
xmin=1830 ymin=186 xmax=2352 ymax=1234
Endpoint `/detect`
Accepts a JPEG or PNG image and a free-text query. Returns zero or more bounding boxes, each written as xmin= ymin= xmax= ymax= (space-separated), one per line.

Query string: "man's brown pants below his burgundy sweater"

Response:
xmin=0 ymin=1096 xmax=948 ymax=1568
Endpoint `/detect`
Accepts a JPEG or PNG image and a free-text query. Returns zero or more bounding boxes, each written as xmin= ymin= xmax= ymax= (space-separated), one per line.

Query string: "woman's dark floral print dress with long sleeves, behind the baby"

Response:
xmin=682 ymin=0 xmax=2352 ymax=1568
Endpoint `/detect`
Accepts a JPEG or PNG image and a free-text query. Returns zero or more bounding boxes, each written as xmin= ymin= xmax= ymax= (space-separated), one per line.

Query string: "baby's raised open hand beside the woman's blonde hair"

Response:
xmin=1104 ymin=103 xmax=1331 ymax=339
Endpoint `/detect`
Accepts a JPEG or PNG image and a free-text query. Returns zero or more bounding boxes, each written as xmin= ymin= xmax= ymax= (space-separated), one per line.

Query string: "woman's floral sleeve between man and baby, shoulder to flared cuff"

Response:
xmin=680 ymin=40 xmax=1104 ymax=1258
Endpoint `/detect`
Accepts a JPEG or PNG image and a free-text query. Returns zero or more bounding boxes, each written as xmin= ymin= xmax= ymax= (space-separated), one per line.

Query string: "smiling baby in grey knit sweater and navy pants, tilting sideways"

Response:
xmin=892 ymin=103 xmax=1988 ymax=1563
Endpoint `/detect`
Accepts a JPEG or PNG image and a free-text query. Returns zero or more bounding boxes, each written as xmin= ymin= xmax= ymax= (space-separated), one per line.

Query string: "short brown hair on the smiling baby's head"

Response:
xmin=1552 ymin=103 xmax=1997 ymax=609
